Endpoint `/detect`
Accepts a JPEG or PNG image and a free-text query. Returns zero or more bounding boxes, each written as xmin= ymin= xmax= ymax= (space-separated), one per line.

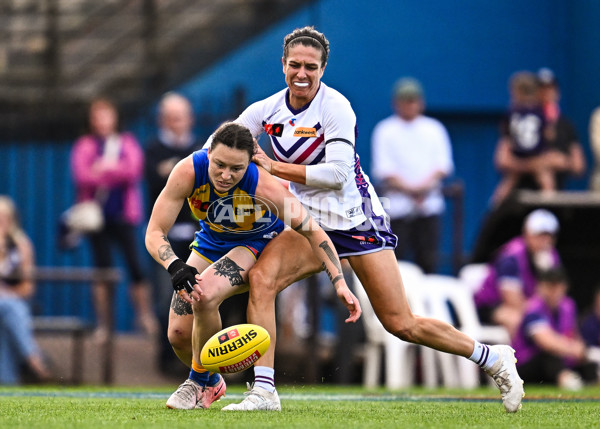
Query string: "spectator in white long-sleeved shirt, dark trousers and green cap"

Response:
xmin=371 ymin=78 xmax=454 ymax=273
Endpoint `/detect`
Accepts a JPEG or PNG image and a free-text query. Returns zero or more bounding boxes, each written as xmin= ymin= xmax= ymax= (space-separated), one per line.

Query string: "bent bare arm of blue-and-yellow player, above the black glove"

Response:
xmin=146 ymin=156 xmax=194 ymax=268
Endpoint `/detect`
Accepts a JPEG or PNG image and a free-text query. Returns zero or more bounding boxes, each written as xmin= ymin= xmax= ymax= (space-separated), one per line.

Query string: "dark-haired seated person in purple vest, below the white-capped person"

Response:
xmin=512 ymin=268 xmax=596 ymax=390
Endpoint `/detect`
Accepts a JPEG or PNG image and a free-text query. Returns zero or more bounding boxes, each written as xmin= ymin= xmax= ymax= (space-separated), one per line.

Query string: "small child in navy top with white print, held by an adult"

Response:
xmin=492 ymin=71 xmax=556 ymax=206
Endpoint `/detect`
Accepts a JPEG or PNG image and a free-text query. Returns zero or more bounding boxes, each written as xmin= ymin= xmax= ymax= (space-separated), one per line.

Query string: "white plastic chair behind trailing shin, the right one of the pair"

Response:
xmin=424 ymin=274 xmax=510 ymax=388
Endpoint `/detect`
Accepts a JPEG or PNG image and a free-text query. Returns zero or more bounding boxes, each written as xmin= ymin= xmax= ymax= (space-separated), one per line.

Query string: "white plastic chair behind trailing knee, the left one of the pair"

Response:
xmin=354 ymin=261 xmax=433 ymax=389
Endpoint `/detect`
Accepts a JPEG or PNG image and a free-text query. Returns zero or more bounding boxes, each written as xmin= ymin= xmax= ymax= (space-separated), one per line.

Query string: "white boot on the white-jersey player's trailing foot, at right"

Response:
xmin=485 ymin=345 xmax=525 ymax=413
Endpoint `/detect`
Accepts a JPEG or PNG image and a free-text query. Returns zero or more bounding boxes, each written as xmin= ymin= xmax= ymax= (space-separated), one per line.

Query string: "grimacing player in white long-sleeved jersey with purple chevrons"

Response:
xmin=224 ymin=27 xmax=524 ymax=412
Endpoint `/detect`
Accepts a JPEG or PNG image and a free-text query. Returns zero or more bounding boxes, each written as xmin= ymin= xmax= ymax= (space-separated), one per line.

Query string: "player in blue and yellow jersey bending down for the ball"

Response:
xmin=146 ymin=123 xmax=361 ymax=409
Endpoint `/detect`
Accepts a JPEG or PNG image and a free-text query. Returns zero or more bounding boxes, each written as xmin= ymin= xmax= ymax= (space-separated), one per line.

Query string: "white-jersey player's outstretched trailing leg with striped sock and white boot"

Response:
xmin=348 ymin=250 xmax=524 ymax=412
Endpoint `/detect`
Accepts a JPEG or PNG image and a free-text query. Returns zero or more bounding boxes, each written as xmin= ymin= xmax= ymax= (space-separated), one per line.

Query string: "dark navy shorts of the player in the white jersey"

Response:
xmin=325 ymin=219 xmax=398 ymax=258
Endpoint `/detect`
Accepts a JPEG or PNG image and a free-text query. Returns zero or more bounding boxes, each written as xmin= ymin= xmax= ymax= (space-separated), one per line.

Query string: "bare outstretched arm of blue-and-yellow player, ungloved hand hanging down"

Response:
xmin=256 ymin=168 xmax=361 ymax=322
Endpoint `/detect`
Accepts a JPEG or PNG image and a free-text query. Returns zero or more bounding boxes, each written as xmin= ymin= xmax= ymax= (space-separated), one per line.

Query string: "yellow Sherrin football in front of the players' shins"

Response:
xmin=200 ymin=324 xmax=271 ymax=374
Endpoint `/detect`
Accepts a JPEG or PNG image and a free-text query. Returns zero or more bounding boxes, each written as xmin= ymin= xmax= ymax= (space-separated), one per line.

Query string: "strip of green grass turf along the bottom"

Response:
xmin=0 ymin=386 xmax=600 ymax=429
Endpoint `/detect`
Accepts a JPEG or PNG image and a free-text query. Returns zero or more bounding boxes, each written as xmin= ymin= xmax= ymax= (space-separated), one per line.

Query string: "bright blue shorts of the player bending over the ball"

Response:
xmin=190 ymin=222 xmax=285 ymax=264
